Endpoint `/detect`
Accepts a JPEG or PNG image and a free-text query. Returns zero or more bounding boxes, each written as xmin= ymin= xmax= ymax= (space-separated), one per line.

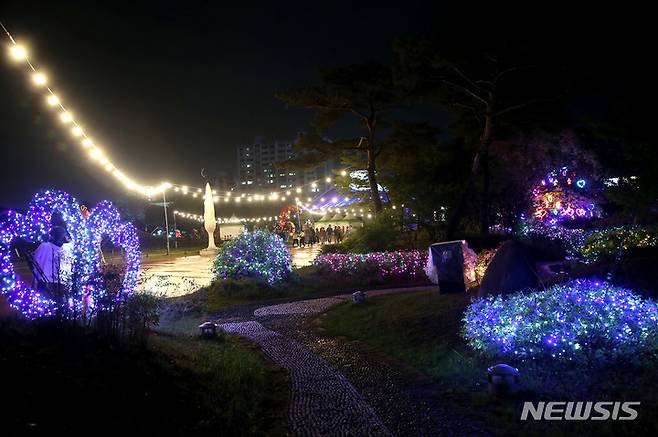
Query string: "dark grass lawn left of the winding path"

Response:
xmin=0 ymin=318 xmax=289 ymax=436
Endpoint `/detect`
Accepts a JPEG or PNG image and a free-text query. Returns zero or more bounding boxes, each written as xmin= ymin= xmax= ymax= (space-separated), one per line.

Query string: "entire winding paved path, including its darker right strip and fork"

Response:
xmin=214 ymin=287 xmax=490 ymax=436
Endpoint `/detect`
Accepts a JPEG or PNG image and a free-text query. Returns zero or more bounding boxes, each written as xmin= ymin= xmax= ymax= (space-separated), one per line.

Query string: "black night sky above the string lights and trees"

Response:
xmin=0 ymin=1 xmax=655 ymax=212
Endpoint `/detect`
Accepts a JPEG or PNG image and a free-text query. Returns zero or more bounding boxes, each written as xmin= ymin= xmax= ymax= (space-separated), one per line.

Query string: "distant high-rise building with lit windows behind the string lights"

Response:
xmin=237 ymin=137 xmax=336 ymax=191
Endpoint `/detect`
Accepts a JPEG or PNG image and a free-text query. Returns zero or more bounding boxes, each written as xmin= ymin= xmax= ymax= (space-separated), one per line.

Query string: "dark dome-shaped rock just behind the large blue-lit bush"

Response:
xmin=480 ymin=240 xmax=540 ymax=296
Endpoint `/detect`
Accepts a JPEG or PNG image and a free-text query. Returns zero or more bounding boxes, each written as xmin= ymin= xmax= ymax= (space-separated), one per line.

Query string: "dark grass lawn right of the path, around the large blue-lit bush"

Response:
xmin=318 ymin=292 xmax=658 ymax=436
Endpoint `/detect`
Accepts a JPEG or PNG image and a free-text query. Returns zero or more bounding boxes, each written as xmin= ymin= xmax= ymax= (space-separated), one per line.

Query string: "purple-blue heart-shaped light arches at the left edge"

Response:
xmin=0 ymin=191 xmax=139 ymax=319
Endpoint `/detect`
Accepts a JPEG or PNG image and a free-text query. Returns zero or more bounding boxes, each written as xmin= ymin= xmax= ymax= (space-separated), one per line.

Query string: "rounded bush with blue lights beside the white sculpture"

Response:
xmin=212 ymin=230 xmax=292 ymax=285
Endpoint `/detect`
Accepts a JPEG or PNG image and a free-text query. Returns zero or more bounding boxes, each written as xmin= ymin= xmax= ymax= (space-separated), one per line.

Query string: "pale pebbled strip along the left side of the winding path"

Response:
xmin=221 ymin=321 xmax=391 ymax=436
